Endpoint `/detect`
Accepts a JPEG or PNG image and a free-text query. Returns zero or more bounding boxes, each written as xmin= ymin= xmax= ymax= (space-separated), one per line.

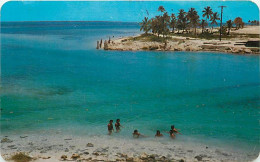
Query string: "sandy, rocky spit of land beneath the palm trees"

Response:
xmin=101 ymin=26 xmax=260 ymax=54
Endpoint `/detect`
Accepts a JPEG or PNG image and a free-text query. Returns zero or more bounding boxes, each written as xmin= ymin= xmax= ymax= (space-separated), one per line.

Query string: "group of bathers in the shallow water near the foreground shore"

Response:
xmin=107 ymin=119 xmax=181 ymax=138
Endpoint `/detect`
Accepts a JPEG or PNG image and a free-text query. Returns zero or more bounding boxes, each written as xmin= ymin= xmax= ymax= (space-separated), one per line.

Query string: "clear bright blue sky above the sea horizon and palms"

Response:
xmin=1 ymin=1 xmax=259 ymax=22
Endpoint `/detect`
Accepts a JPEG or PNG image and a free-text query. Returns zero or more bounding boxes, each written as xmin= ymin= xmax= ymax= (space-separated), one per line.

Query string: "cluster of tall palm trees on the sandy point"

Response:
xmin=140 ymin=6 xmax=244 ymax=37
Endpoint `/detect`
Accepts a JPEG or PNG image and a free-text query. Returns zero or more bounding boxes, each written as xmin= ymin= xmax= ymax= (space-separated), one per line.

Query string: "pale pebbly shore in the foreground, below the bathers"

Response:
xmin=1 ymin=132 xmax=258 ymax=162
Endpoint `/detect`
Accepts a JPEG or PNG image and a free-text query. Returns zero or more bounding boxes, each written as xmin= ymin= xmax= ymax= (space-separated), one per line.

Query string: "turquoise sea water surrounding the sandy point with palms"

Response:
xmin=1 ymin=22 xmax=260 ymax=151
